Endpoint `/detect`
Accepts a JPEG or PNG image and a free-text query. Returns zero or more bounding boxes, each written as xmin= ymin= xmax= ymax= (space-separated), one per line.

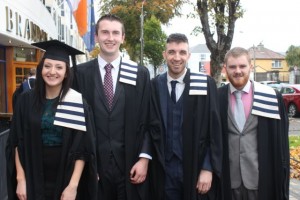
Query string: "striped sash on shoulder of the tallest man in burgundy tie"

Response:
xmin=119 ymin=59 xmax=138 ymax=85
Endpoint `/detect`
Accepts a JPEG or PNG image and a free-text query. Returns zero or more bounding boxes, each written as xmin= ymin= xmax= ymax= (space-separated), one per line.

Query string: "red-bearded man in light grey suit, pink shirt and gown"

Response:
xmin=218 ymin=47 xmax=289 ymax=200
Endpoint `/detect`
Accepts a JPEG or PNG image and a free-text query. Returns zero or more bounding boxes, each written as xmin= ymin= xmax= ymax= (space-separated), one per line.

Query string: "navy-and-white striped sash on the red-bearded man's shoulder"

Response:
xmin=251 ymin=82 xmax=280 ymax=119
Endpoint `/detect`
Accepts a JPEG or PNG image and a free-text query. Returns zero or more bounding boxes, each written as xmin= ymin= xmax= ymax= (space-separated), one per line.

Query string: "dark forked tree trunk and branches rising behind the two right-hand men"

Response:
xmin=195 ymin=0 xmax=244 ymax=84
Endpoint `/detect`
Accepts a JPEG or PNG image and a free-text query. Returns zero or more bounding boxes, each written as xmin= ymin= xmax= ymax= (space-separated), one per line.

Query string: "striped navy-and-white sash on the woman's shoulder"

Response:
xmin=54 ymin=89 xmax=86 ymax=131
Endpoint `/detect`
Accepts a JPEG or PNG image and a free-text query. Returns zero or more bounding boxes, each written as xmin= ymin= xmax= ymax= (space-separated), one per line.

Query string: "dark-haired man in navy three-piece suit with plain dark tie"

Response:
xmin=150 ymin=33 xmax=222 ymax=200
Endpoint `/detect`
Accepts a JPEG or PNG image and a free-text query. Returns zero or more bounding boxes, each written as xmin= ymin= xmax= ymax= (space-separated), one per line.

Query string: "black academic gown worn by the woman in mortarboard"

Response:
xmin=6 ymin=90 xmax=97 ymax=200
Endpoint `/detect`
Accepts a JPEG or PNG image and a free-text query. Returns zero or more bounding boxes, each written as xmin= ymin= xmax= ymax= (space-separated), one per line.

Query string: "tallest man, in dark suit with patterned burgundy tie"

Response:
xmin=74 ymin=14 xmax=151 ymax=200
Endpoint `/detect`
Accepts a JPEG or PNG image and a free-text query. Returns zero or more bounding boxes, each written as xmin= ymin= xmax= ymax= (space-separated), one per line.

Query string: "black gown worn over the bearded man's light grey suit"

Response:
xmin=218 ymin=85 xmax=290 ymax=200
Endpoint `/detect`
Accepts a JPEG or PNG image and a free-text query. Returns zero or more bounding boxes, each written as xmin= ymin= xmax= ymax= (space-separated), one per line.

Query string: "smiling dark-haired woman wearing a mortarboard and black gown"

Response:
xmin=6 ymin=40 xmax=97 ymax=200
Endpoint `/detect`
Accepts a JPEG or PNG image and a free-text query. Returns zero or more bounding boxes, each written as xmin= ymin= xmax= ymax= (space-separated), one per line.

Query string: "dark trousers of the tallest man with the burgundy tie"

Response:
xmin=98 ymin=154 xmax=127 ymax=200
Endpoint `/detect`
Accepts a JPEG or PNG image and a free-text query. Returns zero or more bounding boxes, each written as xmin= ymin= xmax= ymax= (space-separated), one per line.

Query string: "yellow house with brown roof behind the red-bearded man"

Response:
xmin=248 ymin=43 xmax=290 ymax=83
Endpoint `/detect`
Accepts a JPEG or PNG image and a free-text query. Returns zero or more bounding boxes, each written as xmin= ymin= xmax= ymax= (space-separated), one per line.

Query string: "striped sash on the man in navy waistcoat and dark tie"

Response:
xmin=189 ymin=72 xmax=207 ymax=95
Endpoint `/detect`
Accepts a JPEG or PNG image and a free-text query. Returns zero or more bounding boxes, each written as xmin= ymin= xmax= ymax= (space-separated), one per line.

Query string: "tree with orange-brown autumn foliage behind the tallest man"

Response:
xmin=100 ymin=0 xmax=188 ymax=61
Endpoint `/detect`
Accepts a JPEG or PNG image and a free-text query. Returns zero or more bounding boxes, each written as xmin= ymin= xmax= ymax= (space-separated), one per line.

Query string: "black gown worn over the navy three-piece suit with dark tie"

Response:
xmin=150 ymin=70 xmax=222 ymax=200
